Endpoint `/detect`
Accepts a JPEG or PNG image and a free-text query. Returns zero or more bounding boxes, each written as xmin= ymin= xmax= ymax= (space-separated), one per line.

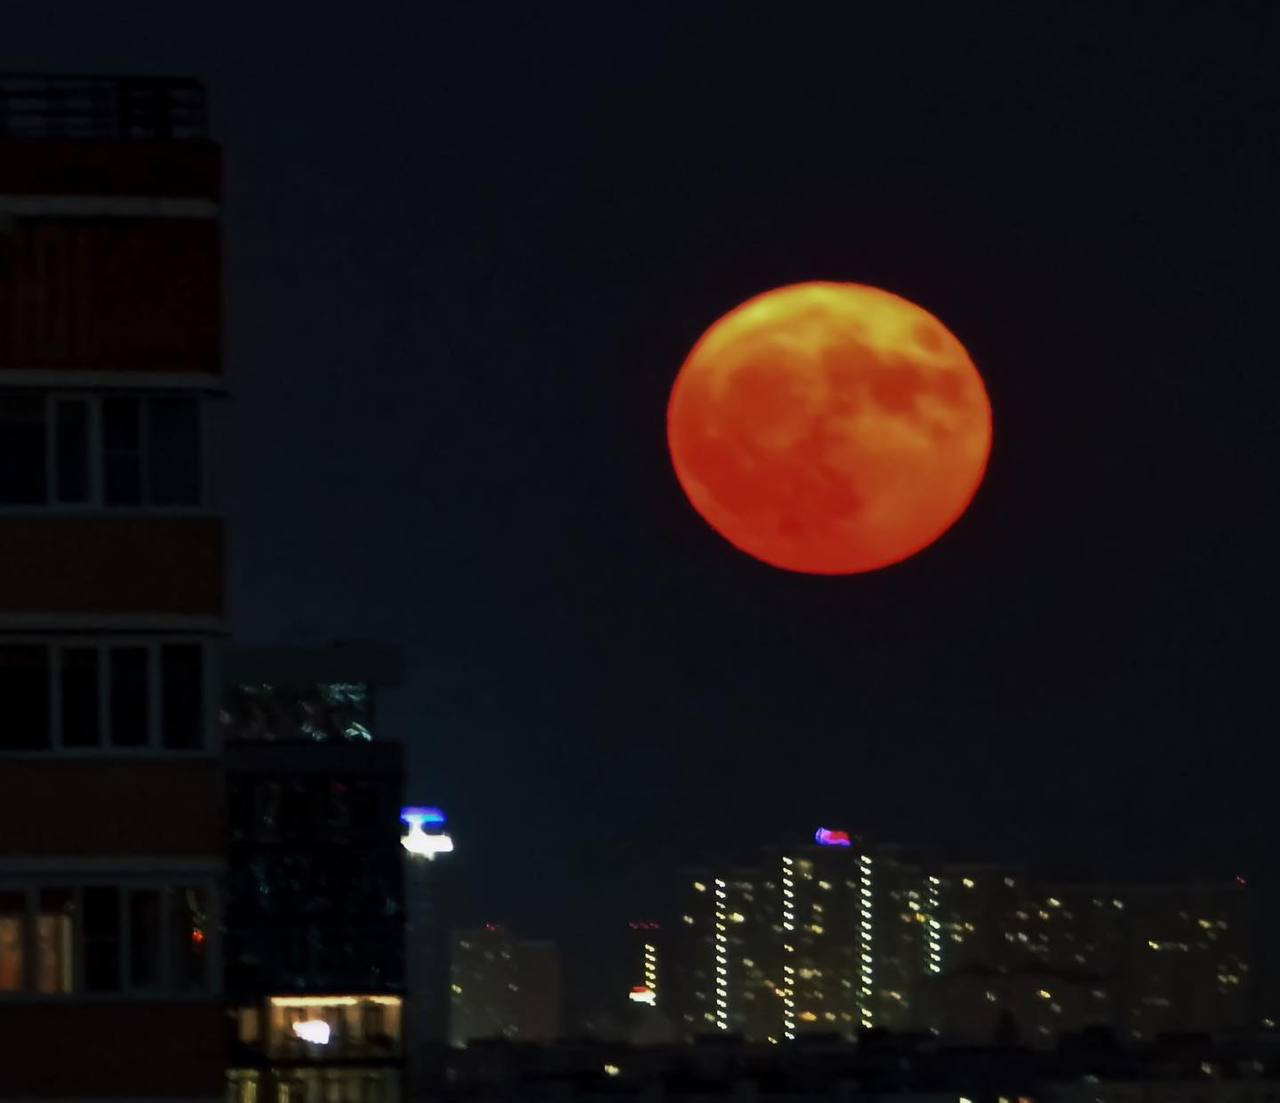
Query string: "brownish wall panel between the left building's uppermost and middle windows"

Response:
xmin=0 ymin=516 xmax=224 ymax=618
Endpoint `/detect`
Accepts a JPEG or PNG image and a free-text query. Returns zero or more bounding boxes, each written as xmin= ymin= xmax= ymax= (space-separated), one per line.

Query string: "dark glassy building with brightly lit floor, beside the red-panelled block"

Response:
xmin=221 ymin=645 xmax=404 ymax=1103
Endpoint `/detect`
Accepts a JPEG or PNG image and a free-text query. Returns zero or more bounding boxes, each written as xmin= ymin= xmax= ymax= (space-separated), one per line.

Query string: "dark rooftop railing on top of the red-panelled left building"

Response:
xmin=0 ymin=74 xmax=209 ymax=142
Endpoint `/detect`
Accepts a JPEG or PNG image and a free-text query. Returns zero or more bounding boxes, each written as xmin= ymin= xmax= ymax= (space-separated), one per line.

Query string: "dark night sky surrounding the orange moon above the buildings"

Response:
xmin=0 ymin=0 xmax=1280 ymax=1013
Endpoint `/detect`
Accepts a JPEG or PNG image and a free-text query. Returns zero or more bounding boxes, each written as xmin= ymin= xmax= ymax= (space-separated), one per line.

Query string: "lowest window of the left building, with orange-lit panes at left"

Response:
xmin=0 ymin=879 xmax=214 ymax=998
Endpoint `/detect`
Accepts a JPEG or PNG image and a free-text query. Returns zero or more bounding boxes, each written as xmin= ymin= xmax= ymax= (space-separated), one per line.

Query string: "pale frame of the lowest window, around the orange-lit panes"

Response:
xmin=0 ymin=870 xmax=223 ymax=1006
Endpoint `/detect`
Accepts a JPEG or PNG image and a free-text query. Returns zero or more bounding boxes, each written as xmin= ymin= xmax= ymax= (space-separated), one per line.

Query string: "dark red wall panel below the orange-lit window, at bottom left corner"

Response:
xmin=0 ymin=1002 xmax=227 ymax=1099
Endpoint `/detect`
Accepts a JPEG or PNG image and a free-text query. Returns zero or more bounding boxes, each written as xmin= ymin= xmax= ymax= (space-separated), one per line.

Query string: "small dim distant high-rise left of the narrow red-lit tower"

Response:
xmin=449 ymin=923 xmax=561 ymax=1045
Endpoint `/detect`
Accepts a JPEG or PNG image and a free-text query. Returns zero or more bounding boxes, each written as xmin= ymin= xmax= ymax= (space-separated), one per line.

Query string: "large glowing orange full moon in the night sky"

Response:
xmin=667 ymin=283 xmax=991 ymax=575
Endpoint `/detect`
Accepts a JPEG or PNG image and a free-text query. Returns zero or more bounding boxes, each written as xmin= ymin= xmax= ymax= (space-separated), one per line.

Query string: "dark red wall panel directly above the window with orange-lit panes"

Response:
xmin=0 ymin=752 xmax=225 ymax=859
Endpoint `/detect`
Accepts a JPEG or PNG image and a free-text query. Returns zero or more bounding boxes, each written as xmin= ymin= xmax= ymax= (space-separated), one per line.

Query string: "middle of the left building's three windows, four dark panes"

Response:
xmin=0 ymin=640 xmax=210 ymax=752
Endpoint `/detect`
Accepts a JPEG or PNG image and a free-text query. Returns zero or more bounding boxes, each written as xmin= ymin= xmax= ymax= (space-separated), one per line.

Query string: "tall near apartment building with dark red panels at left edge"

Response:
xmin=0 ymin=77 xmax=225 ymax=1100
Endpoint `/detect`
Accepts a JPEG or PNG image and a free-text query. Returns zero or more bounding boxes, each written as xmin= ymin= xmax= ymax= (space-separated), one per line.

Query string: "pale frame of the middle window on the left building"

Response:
xmin=0 ymin=633 xmax=219 ymax=760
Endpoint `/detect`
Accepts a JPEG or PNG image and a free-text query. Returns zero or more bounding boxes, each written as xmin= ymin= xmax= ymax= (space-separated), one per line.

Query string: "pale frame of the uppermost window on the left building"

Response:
xmin=0 ymin=388 xmax=215 ymax=517
